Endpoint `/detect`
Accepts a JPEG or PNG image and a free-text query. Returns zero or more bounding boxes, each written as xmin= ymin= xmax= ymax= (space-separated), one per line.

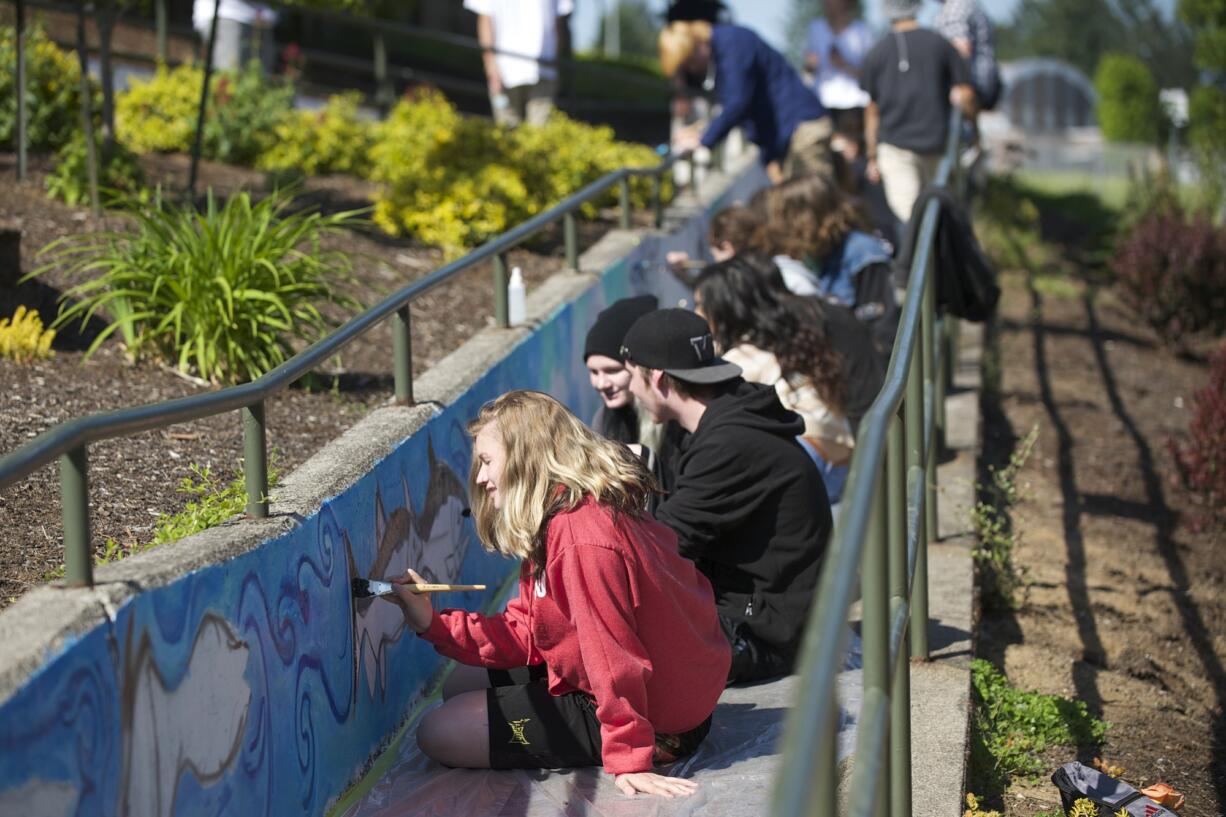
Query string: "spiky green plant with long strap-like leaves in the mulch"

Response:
xmin=36 ymin=191 xmax=359 ymax=383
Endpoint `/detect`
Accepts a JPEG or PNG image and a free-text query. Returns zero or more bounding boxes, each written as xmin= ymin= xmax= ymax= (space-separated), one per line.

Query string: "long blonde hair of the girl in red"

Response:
xmin=468 ymin=390 xmax=656 ymax=575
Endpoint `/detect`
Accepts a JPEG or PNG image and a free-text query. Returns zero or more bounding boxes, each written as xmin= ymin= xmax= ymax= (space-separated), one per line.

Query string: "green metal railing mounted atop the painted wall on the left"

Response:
xmin=0 ymin=141 xmax=711 ymax=586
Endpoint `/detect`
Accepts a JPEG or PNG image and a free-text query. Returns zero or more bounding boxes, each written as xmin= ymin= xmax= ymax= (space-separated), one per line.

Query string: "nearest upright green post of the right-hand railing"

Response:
xmin=859 ymin=466 xmax=890 ymax=815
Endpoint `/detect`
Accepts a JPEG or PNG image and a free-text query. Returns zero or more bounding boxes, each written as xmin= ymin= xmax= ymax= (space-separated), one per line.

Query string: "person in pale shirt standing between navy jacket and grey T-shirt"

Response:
xmin=804 ymin=0 xmax=873 ymax=163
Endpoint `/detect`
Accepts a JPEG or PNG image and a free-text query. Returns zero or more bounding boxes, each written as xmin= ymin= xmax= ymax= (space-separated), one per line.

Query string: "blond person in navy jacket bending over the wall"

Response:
xmin=660 ymin=20 xmax=834 ymax=184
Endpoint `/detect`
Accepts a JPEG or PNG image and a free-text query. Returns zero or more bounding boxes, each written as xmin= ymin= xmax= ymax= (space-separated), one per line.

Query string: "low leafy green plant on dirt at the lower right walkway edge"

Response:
xmin=971 ymin=659 xmax=1107 ymax=775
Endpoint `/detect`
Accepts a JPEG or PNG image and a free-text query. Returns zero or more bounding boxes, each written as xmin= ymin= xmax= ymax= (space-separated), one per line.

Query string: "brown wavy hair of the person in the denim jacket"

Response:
xmin=756 ymin=175 xmax=867 ymax=266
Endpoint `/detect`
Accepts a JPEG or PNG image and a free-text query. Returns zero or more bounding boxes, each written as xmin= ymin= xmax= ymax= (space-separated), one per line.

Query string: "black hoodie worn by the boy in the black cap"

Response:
xmin=656 ymin=379 xmax=831 ymax=654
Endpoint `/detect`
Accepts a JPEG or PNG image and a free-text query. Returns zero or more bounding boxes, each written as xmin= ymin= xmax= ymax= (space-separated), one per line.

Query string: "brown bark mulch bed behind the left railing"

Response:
xmin=0 ymin=153 xmax=622 ymax=607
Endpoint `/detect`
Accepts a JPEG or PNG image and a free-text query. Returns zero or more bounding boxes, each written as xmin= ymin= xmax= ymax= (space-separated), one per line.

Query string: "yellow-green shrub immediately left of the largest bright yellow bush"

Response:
xmin=256 ymin=91 xmax=375 ymax=177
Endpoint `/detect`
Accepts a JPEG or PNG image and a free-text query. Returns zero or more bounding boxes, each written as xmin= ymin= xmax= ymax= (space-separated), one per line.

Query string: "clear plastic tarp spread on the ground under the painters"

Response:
xmin=343 ymin=639 xmax=862 ymax=817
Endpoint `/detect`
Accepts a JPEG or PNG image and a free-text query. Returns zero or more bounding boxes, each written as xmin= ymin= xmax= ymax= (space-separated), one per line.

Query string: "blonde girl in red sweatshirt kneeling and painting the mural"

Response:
xmin=396 ymin=391 xmax=729 ymax=797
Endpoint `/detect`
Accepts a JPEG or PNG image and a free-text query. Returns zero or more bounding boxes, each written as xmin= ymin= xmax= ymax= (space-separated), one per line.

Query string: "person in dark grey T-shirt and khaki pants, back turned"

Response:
xmin=861 ymin=0 xmax=975 ymax=223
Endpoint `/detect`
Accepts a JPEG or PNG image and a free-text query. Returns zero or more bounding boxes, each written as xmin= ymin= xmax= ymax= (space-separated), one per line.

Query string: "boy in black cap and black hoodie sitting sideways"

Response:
xmin=622 ymin=309 xmax=831 ymax=683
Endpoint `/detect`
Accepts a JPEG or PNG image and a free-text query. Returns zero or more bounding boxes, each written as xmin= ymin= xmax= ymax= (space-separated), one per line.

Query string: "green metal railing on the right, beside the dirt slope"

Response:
xmin=771 ymin=110 xmax=961 ymax=817
